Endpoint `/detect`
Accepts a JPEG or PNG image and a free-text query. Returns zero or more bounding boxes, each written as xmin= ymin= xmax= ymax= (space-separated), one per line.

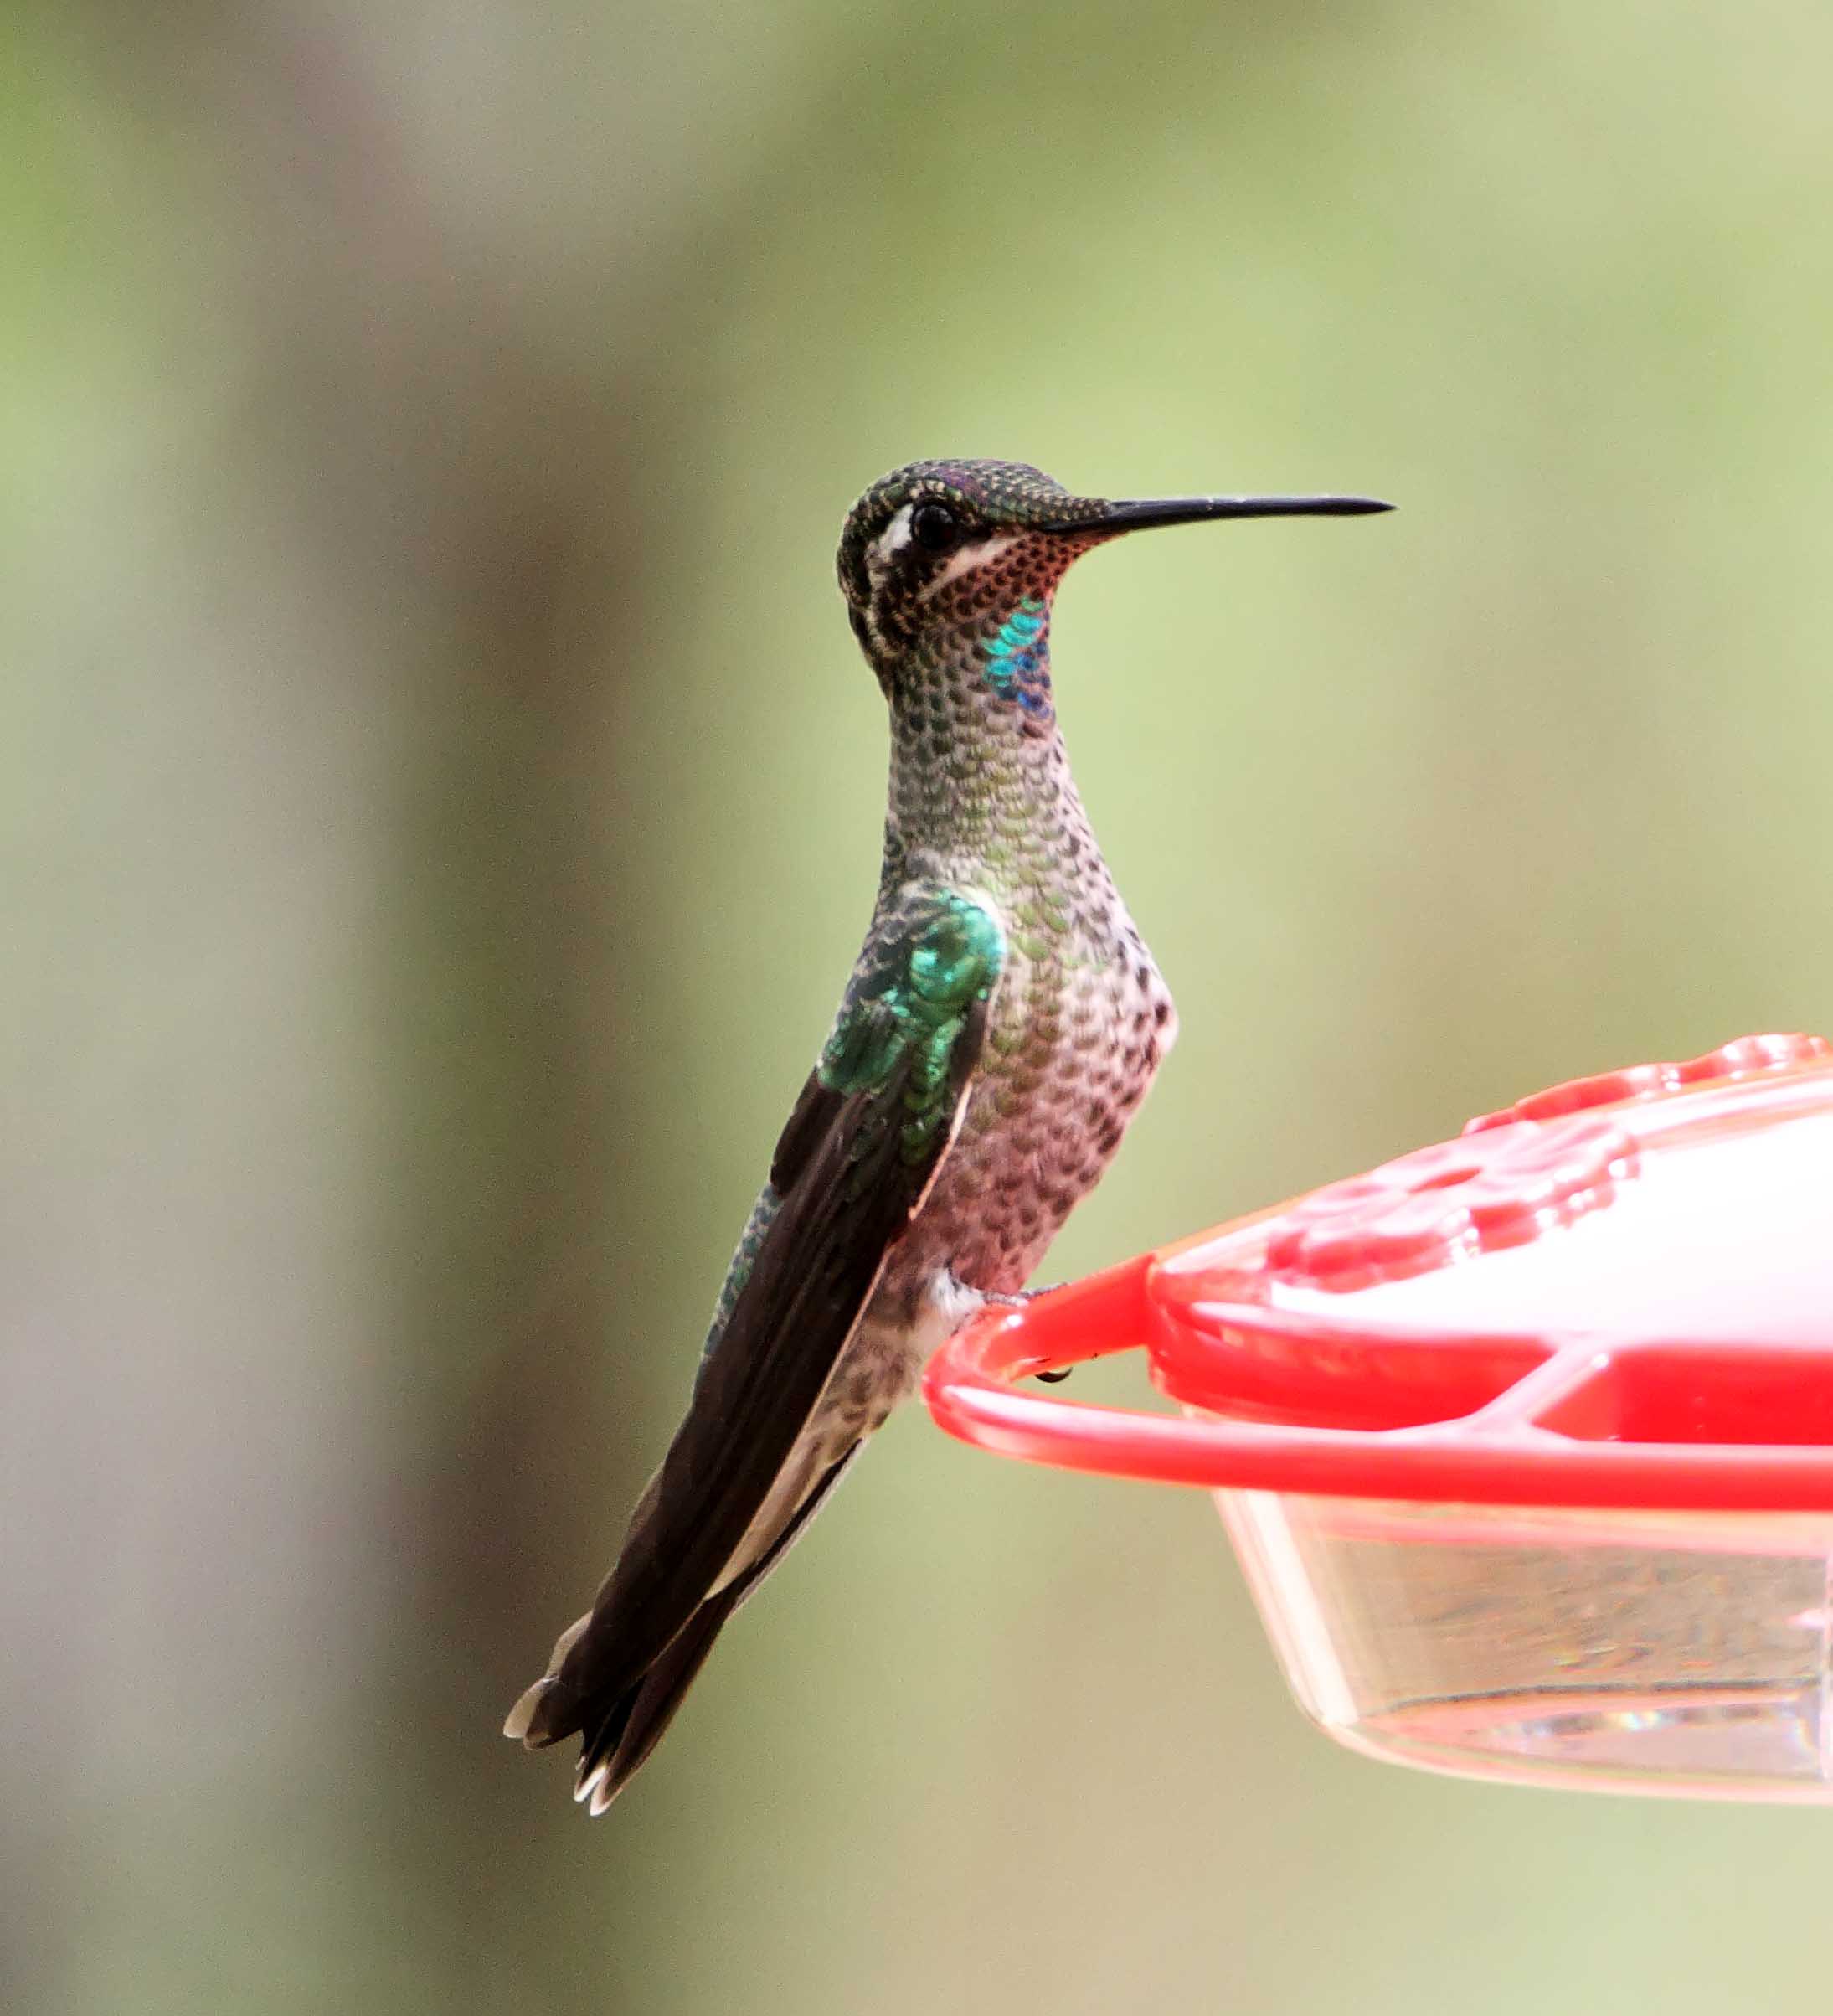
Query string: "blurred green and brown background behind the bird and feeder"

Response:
xmin=14 ymin=0 xmax=1833 ymax=2016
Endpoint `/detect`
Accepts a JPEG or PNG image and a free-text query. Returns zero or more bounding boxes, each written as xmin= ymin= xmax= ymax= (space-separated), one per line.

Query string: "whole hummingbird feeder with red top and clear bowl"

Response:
xmin=925 ymin=1036 xmax=1833 ymax=1802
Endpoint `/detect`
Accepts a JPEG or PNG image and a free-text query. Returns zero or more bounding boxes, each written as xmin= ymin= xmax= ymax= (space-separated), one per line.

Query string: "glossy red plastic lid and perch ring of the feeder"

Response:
xmin=929 ymin=1036 xmax=1833 ymax=1510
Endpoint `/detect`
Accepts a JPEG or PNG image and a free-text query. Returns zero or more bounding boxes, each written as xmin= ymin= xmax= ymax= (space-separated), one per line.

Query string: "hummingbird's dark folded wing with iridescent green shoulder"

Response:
xmin=508 ymin=889 xmax=1004 ymax=1781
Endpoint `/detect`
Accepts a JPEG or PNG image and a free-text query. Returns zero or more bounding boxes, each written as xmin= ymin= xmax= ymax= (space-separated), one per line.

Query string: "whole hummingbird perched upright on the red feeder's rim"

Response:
xmin=504 ymin=461 xmax=1389 ymax=1817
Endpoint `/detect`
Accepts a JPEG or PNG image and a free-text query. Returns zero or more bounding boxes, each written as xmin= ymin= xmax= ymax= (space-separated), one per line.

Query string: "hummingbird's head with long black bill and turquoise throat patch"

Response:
xmin=839 ymin=461 xmax=1392 ymax=734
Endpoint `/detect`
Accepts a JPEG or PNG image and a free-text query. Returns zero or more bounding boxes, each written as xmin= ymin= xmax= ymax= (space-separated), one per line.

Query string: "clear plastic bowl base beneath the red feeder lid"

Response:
xmin=1216 ymin=1490 xmax=1833 ymax=1804
